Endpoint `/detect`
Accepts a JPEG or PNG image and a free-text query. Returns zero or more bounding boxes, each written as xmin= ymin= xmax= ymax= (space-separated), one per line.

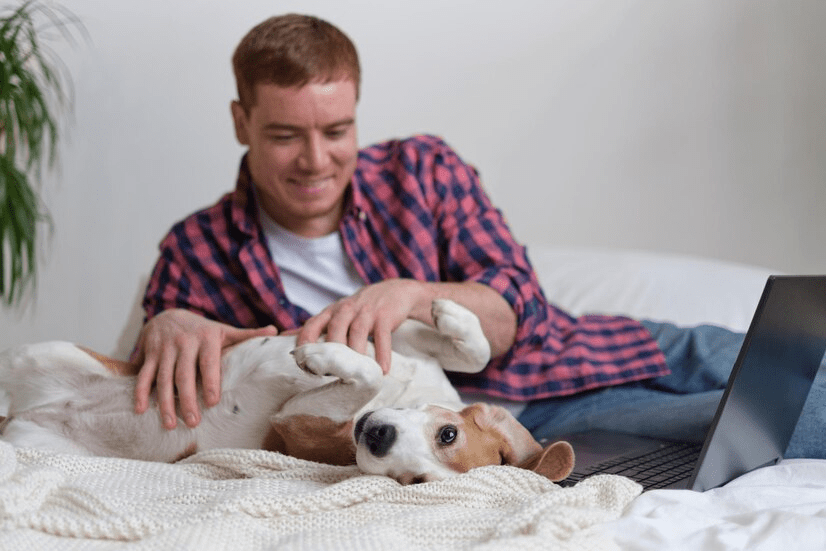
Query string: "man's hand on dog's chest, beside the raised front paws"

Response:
xmin=296 ymin=279 xmax=424 ymax=373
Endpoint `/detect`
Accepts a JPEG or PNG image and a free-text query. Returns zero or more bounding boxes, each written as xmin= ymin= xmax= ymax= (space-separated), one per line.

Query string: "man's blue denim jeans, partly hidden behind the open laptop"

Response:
xmin=519 ymin=321 xmax=826 ymax=459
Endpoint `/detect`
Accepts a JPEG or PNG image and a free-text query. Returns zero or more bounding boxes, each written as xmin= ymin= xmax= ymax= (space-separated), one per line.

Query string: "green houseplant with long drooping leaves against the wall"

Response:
xmin=0 ymin=0 xmax=82 ymax=306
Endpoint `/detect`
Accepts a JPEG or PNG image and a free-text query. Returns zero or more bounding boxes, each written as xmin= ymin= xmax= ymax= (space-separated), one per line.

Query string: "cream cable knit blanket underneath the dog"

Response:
xmin=0 ymin=442 xmax=640 ymax=550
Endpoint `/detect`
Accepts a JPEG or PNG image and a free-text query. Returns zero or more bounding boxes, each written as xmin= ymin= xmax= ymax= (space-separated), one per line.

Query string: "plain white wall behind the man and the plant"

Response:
xmin=0 ymin=0 xmax=826 ymax=355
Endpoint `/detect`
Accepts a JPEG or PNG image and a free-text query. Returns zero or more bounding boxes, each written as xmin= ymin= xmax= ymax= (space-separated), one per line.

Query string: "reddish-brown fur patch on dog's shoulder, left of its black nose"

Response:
xmin=261 ymin=415 xmax=356 ymax=465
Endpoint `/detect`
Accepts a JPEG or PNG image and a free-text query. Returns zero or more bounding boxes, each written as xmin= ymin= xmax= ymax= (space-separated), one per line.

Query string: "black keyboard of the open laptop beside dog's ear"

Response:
xmin=564 ymin=442 xmax=702 ymax=490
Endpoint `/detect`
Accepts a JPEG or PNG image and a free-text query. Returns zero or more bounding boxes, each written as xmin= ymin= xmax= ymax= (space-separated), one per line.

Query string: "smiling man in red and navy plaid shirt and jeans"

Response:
xmin=135 ymin=15 xmax=816 ymax=460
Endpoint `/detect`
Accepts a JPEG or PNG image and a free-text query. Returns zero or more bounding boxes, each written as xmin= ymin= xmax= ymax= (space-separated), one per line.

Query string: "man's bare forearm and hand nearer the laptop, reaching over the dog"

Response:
xmin=298 ymin=279 xmax=516 ymax=373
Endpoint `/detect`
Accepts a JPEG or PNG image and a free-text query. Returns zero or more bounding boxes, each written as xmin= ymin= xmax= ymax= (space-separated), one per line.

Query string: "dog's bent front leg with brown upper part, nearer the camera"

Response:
xmin=265 ymin=343 xmax=383 ymax=465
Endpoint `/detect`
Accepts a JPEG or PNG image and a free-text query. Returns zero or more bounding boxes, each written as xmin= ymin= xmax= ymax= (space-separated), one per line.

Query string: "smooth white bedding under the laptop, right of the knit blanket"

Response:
xmin=601 ymin=459 xmax=826 ymax=551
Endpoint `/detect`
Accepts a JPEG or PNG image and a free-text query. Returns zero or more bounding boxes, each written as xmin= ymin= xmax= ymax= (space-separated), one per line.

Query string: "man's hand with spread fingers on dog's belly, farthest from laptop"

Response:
xmin=135 ymin=310 xmax=278 ymax=429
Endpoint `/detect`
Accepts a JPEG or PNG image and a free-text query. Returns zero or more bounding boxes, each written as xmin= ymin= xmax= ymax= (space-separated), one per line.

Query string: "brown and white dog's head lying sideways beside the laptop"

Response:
xmin=353 ymin=403 xmax=574 ymax=484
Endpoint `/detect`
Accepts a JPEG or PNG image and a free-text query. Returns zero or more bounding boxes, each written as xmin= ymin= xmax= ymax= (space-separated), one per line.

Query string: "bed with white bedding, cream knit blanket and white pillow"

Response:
xmin=0 ymin=246 xmax=826 ymax=551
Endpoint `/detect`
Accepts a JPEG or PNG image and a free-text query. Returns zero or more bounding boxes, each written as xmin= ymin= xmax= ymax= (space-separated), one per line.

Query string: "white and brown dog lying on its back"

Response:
xmin=0 ymin=300 xmax=574 ymax=484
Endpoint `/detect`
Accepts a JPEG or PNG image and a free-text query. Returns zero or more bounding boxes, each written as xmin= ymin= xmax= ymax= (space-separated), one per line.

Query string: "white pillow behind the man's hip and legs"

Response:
xmin=528 ymin=245 xmax=779 ymax=332
